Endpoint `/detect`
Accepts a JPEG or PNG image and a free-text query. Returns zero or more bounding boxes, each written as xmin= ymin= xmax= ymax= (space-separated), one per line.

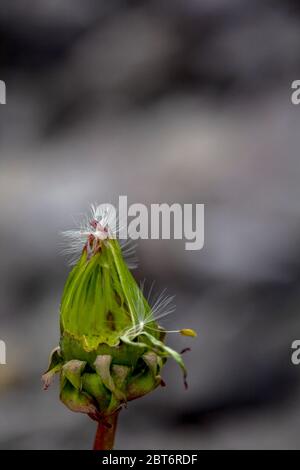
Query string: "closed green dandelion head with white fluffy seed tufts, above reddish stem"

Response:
xmin=43 ymin=204 xmax=195 ymax=421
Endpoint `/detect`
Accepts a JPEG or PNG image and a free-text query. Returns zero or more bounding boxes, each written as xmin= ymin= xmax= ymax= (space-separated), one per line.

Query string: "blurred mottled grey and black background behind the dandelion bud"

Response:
xmin=0 ymin=0 xmax=300 ymax=449
